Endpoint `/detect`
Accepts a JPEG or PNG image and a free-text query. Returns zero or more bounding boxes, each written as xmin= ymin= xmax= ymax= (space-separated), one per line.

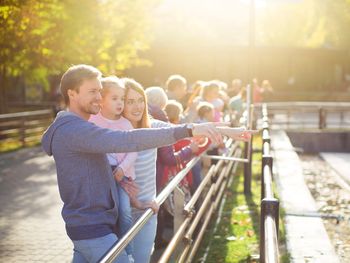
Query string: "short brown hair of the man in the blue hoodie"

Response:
xmin=60 ymin=64 xmax=102 ymax=105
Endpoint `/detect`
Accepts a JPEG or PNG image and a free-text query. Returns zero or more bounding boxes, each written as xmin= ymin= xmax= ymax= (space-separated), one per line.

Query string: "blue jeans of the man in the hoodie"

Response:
xmin=73 ymin=234 xmax=129 ymax=263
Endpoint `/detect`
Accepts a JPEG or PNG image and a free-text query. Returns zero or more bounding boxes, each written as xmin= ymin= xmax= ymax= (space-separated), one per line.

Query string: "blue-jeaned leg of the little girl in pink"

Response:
xmin=117 ymin=183 xmax=133 ymax=255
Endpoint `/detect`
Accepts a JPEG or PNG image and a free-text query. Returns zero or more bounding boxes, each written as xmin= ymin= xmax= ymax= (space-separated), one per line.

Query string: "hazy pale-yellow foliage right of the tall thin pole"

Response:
xmin=257 ymin=0 xmax=350 ymax=48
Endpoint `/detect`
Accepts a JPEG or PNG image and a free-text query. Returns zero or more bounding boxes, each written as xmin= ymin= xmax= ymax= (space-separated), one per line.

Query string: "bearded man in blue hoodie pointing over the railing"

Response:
xmin=42 ymin=65 xmax=227 ymax=262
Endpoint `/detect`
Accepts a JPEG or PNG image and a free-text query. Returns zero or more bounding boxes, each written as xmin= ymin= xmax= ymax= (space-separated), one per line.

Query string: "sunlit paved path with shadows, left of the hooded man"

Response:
xmin=0 ymin=147 xmax=72 ymax=262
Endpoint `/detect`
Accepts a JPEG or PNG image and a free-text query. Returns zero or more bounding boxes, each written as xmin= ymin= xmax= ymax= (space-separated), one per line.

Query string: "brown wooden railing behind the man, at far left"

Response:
xmin=0 ymin=110 xmax=53 ymax=146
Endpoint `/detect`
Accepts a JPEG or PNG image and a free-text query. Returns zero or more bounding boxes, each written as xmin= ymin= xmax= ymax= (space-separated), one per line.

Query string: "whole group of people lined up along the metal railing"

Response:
xmin=42 ymin=65 xmax=258 ymax=263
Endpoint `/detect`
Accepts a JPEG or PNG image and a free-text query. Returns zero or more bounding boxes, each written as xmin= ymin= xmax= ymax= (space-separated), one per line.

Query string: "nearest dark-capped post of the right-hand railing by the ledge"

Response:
xmin=259 ymin=198 xmax=279 ymax=263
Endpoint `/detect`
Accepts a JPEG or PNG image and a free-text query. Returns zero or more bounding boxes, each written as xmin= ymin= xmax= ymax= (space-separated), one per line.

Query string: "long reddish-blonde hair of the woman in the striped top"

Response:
xmin=121 ymin=78 xmax=151 ymax=128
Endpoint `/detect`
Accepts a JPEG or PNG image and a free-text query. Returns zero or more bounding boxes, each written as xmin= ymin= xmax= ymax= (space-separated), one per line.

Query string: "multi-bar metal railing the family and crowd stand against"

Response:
xmin=99 ymin=136 xmax=241 ymax=263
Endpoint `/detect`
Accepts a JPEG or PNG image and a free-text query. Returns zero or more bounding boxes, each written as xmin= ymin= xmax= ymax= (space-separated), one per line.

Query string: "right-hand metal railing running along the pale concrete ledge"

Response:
xmin=260 ymin=104 xmax=279 ymax=263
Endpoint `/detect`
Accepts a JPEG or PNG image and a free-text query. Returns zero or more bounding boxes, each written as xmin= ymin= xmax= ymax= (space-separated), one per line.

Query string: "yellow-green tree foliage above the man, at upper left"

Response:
xmin=0 ymin=0 xmax=156 ymax=93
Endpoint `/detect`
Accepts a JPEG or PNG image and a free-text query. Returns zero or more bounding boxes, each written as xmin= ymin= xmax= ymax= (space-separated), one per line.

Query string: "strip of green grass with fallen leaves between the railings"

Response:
xmin=196 ymin=136 xmax=289 ymax=263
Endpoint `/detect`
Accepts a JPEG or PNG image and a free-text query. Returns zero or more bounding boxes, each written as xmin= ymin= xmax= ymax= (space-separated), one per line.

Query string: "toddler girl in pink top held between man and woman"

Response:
xmin=89 ymin=76 xmax=137 ymax=262
